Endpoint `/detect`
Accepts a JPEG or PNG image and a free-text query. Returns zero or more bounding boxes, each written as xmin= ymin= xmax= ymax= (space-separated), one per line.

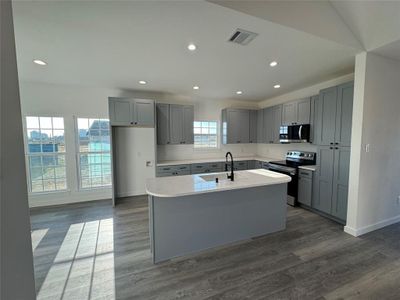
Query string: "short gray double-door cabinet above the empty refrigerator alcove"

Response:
xmin=108 ymin=97 xmax=154 ymax=127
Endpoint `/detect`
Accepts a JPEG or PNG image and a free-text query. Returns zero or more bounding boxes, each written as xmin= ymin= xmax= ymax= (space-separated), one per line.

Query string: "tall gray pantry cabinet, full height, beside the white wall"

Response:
xmin=312 ymin=82 xmax=353 ymax=220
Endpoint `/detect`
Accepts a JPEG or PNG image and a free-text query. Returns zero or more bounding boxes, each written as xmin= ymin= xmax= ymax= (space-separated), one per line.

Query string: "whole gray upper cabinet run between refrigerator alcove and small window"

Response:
xmin=157 ymin=103 xmax=194 ymax=145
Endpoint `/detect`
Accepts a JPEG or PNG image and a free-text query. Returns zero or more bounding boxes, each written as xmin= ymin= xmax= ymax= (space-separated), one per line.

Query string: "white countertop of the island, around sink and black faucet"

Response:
xmin=146 ymin=169 xmax=291 ymax=198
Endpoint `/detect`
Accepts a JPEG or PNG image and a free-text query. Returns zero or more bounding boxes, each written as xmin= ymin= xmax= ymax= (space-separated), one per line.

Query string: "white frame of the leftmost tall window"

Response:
xmin=22 ymin=113 xmax=69 ymax=195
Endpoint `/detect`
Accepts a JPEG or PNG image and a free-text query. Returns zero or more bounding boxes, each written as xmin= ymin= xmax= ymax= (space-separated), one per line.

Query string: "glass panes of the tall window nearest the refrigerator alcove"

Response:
xmin=77 ymin=118 xmax=111 ymax=189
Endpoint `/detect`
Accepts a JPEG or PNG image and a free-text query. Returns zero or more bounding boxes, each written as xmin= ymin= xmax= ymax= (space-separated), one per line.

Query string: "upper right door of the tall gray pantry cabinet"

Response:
xmin=335 ymin=82 xmax=354 ymax=147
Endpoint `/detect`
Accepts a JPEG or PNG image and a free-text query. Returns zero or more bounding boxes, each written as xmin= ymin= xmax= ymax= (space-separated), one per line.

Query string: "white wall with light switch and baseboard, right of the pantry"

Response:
xmin=345 ymin=53 xmax=400 ymax=235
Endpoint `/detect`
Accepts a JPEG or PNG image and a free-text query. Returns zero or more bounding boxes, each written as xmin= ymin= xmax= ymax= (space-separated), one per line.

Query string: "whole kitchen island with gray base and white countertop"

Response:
xmin=146 ymin=169 xmax=291 ymax=263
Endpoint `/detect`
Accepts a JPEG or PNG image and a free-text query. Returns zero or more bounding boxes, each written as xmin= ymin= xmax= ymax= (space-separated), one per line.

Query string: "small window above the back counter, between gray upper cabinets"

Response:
xmin=193 ymin=121 xmax=218 ymax=148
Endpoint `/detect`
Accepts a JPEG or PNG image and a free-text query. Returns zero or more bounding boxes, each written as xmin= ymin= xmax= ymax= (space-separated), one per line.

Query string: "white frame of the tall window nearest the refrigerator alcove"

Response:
xmin=74 ymin=116 xmax=113 ymax=191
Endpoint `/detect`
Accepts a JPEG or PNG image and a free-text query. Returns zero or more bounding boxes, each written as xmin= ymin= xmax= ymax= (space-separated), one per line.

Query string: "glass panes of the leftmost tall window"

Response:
xmin=26 ymin=116 xmax=67 ymax=193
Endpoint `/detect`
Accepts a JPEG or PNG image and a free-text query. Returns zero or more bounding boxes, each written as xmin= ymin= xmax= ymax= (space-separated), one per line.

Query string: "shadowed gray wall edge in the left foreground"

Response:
xmin=0 ymin=1 xmax=36 ymax=300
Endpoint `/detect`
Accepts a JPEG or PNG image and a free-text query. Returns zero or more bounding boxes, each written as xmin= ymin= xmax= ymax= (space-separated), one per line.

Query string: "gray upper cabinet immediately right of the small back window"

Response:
xmin=222 ymin=108 xmax=250 ymax=144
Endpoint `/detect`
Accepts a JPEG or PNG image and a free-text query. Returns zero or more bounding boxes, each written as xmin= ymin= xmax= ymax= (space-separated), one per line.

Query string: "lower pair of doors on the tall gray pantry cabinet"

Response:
xmin=312 ymin=146 xmax=350 ymax=220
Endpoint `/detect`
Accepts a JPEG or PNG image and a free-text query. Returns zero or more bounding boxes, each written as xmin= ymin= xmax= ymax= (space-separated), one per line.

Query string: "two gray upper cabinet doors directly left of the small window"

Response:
xmin=169 ymin=104 xmax=194 ymax=145
